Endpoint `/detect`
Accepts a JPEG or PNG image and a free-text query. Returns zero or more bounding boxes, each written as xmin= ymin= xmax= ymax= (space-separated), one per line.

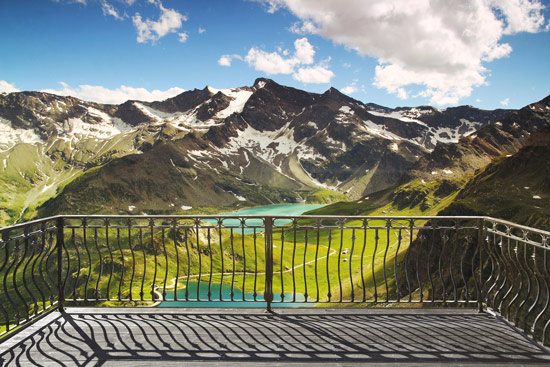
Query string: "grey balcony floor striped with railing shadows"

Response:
xmin=0 ymin=308 xmax=550 ymax=367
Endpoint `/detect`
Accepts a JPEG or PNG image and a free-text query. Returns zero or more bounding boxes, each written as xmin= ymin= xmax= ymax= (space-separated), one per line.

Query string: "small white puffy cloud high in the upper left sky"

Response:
xmin=132 ymin=0 xmax=187 ymax=43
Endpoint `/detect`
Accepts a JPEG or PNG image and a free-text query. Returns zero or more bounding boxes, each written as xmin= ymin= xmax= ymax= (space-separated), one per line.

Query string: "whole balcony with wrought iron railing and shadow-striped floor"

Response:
xmin=0 ymin=216 xmax=550 ymax=366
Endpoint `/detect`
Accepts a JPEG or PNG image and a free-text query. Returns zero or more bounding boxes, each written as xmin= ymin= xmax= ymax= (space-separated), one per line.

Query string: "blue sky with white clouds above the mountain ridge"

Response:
xmin=0 ymin=0 xmax=550 ymax=108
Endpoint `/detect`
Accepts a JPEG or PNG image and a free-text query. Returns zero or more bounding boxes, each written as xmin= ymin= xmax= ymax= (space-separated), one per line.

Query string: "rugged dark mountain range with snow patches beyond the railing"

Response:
xmin=0 ymin=78 xmax=550 ymax=224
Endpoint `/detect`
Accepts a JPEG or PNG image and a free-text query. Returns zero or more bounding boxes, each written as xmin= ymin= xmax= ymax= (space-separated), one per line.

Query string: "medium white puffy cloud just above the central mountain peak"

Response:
xmin=243 ymin=37 xmax=334 ymax=84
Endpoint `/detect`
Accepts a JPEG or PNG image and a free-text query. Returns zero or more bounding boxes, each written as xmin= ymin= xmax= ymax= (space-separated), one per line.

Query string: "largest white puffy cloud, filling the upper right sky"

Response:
xmin=263 ymin=0 xmax=545 ymax=104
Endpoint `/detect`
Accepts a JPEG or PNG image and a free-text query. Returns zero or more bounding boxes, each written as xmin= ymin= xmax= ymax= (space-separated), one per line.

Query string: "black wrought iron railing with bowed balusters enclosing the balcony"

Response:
xmin=0 ymin=215 xmax=550 ymax=344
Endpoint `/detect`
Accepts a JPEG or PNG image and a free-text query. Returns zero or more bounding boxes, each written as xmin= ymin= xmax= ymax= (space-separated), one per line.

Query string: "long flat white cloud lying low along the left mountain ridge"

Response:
xmin=41 ymin=82 xmax=185 ymax=104
